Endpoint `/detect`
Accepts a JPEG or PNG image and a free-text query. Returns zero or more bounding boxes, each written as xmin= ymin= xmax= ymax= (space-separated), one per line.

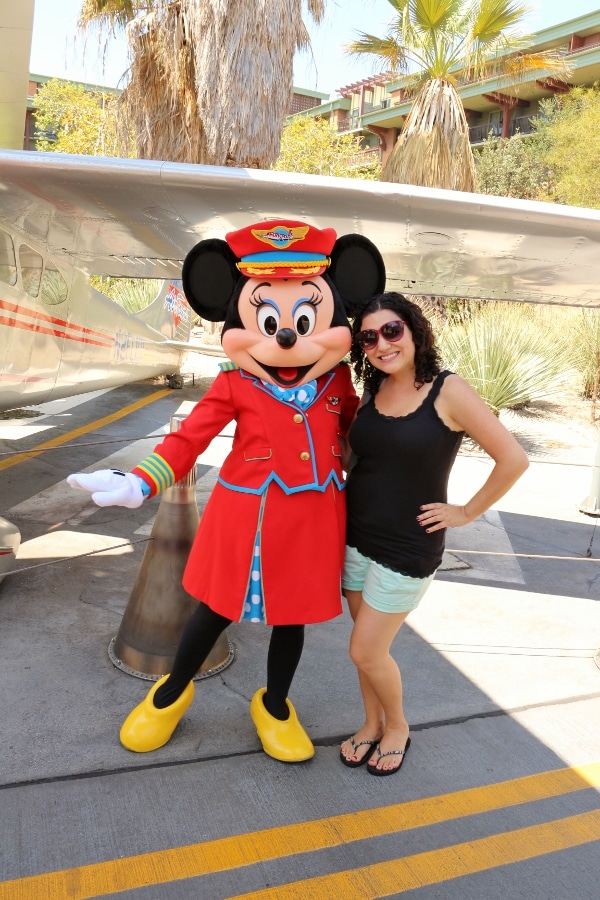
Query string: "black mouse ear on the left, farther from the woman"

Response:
xmin=181 ymin=238 xmax=241 ymax=322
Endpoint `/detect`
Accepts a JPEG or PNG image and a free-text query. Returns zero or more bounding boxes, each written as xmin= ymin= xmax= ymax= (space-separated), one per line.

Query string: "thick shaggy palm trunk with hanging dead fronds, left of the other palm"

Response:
xmin=80 ymin=0 xmax=325 ymax=168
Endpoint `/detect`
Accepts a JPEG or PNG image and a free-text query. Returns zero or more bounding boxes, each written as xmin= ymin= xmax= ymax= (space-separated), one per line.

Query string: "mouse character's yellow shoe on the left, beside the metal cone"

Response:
xmin=119 ymin=675 xmax=194 ymax=753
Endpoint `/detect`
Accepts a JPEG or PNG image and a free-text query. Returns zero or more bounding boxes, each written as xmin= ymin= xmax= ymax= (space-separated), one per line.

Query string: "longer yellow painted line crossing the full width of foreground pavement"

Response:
xmin=0 ymin=762 xmax=600 ymax=900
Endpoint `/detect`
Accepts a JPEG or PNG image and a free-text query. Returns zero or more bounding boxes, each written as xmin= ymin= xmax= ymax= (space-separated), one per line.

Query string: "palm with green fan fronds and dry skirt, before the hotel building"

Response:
xmin=346 ymin=0 xmax=569 ymax=191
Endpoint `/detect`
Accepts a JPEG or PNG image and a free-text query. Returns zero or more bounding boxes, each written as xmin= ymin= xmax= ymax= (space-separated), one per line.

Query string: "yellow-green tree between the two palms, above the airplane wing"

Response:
xmin=273 ymin=116 xmax=381 ymax=180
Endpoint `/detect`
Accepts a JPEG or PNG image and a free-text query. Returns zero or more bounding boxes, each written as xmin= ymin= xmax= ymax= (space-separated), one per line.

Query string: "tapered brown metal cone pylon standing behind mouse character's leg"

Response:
xmin=108 ymin=416 xmax=233 ymax=681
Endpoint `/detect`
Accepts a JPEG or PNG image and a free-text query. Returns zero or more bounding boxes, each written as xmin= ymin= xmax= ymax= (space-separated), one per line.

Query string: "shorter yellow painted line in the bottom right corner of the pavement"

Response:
xmin=227 ymin=810 xmax=600 ymax=900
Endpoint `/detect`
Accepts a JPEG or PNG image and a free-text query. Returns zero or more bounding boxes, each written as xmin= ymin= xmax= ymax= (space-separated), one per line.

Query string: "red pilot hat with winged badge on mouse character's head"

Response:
xmin=225 ymin=219 xmax=337 ymax=278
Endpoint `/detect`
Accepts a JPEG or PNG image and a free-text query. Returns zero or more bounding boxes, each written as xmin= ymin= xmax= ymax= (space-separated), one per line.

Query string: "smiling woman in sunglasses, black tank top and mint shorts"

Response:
xmin=340 ymin=293 xmax=529 ymax=775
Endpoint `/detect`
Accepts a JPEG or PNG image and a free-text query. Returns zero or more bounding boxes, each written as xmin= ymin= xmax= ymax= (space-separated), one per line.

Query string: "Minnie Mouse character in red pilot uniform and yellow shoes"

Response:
xmin=68 ymin=220 xmax=385 ymax=762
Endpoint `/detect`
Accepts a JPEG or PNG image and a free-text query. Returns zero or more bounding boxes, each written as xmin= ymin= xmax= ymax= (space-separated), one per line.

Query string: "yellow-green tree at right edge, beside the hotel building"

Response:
xmin=533 ymin=84 xmax=600 ymax=209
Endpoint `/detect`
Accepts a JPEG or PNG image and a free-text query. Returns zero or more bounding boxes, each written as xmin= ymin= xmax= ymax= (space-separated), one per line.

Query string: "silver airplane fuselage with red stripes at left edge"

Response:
xmin=0 ymin=152 xmax=191 ymax=410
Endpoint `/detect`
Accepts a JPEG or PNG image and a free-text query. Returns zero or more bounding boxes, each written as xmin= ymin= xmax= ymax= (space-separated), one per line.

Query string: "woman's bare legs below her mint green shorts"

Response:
xmin=340 ymin=598 xmax=409 ymax=769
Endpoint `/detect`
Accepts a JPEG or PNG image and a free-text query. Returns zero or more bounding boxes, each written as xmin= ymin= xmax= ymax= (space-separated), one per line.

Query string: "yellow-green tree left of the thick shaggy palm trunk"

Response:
xmin=35 ymin=78 xmax=119 ymax=156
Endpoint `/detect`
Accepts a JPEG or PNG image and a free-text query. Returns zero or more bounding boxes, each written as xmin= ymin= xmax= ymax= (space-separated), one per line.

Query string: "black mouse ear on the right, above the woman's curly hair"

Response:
xmin=327 ymin=234 xmax=385 ymax=313
